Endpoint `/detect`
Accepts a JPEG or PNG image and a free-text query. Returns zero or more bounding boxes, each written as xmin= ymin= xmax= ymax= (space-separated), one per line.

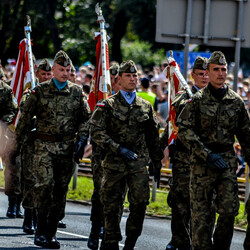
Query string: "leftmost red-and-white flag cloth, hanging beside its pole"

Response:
xmin=10 ymin=38 xmax=31 ymax=127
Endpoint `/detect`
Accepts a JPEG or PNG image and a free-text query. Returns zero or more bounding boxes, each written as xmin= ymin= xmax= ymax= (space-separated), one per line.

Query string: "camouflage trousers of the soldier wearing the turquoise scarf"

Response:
xmin=34 ymin=142 xmax=75 ymax=222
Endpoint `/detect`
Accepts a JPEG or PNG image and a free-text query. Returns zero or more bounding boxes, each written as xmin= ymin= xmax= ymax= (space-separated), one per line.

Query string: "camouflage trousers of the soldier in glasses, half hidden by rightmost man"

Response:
xmin=168 ymin=161 xmax=191 ymax=247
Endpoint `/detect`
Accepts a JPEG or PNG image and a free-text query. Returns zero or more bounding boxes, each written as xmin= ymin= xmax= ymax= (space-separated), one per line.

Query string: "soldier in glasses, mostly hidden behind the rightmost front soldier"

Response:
xmin=160 ymin=57 xmax=208 ymax=250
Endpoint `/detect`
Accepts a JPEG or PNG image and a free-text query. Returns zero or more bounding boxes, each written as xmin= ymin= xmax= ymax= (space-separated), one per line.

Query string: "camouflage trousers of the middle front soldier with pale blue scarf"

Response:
xmin=101 ymin=167 xmax=150 ymax=243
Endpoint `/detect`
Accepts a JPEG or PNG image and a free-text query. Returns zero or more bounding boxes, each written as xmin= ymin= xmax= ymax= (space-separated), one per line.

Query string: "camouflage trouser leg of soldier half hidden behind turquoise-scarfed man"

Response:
xmin=21 ymin=141 xmax=35 ymax=209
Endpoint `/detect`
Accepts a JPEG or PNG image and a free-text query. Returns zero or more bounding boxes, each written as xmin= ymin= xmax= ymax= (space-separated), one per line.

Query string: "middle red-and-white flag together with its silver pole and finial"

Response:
xmin=88 ymin=4 xmax=111 ymax=111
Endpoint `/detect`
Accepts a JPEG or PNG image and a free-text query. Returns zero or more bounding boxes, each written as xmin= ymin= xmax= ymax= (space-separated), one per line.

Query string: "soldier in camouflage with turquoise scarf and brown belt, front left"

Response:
xmin=16 ymin=51 xmax=90 ymax=249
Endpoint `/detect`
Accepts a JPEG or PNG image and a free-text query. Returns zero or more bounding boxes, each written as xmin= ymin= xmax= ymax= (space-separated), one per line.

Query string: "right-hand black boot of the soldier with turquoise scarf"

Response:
xmin=43 ymin=220 xmax=60 ymax=249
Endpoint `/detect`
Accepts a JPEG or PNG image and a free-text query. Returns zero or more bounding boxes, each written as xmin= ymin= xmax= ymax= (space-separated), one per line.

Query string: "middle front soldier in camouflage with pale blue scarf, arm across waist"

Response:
xmin=90 ymin=60 xmax=163 ymax=250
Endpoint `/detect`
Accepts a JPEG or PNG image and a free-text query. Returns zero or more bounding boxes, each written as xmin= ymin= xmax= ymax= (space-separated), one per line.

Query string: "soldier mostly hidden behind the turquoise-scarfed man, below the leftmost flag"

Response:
xmin=20 ymin=58 xmax=52 ymax=234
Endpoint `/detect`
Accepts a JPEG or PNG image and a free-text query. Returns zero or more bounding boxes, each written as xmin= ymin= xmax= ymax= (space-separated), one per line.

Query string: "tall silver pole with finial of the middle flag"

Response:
xmin=95 ymin=3 xmax=109 ymax=99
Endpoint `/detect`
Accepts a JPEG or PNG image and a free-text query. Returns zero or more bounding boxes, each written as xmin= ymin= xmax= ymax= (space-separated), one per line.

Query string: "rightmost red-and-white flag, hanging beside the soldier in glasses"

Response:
xmin=164 ymin=58 xmax=182 ymax=145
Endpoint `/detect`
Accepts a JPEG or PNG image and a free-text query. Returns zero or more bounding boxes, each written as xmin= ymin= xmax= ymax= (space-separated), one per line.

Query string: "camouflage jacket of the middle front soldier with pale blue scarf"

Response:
xmin=90 ymin=92 xmax=163 ymax=171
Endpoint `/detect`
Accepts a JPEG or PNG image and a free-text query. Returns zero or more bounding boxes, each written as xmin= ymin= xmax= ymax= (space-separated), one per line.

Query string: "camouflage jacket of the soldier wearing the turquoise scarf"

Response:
xmin=16 ymin=80 xmax=90 ymax=146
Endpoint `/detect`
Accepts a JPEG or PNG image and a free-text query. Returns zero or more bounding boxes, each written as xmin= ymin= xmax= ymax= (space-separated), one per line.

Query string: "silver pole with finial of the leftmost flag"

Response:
xmin=24 ymin=15 xmax=35 ymax=89
